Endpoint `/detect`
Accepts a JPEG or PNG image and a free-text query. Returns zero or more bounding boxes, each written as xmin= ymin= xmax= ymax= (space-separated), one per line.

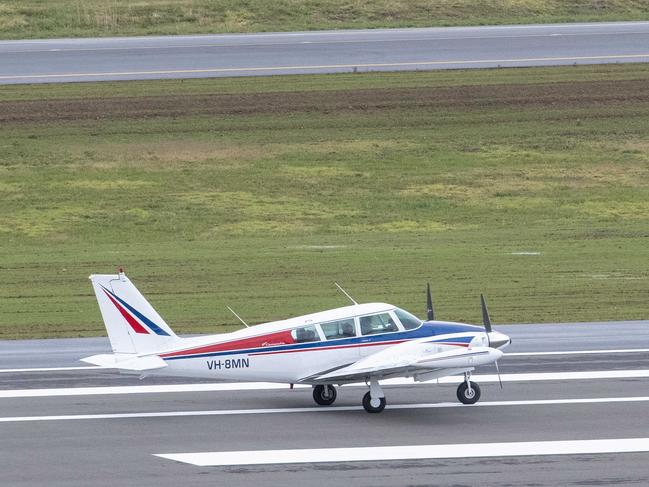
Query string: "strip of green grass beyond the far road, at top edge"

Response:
xmin=0 ymin=0 xmax=649 ymax=39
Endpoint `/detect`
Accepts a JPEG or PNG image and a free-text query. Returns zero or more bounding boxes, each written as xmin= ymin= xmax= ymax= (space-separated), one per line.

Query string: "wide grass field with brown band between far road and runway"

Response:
xmin=0 ymin=64 xmax=649 ymax=338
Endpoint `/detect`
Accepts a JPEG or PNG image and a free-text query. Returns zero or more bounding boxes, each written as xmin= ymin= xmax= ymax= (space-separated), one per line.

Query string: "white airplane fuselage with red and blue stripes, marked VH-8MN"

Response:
xmin=144 ymin=303 xmax=493 ymax=383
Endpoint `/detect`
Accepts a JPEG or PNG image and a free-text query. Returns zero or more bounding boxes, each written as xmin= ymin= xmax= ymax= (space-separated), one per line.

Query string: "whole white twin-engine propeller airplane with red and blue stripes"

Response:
xmin=83 ymin=269 xmax=510 ymax=413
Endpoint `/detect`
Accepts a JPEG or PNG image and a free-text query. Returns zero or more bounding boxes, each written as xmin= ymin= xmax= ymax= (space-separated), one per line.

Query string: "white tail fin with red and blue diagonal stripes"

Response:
xmin=90 ymin=269 xmax=180 ymax=354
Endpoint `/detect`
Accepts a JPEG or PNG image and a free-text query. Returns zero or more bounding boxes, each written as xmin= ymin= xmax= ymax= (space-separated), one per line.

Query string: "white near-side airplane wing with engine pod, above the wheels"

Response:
xmin=300 ymin=338 xmax=503 ymax=384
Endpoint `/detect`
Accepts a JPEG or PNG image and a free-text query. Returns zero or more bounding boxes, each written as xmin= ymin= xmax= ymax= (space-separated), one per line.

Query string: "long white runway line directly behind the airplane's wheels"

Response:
xmin=0 ymin=369 xmax=649 ymax=398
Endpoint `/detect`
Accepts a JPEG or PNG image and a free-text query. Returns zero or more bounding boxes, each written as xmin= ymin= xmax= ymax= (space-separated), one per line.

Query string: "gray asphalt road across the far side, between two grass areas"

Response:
xmin=0 ymin=22 xmax=649 ymax=84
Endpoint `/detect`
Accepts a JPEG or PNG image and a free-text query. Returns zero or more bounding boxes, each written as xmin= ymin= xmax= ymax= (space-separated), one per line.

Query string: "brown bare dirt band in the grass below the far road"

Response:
xmin=0 ymin=80 xmax=649 ymax=124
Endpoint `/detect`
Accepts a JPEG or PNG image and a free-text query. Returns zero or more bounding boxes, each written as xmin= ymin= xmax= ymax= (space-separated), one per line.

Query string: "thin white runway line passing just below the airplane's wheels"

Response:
xmin=0 ymin=396 xmax=649 ymax=423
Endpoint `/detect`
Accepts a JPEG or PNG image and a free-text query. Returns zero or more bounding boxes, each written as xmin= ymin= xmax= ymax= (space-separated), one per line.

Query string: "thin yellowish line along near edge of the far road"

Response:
xmin=0 ymin=53 xmax=649 ymax=80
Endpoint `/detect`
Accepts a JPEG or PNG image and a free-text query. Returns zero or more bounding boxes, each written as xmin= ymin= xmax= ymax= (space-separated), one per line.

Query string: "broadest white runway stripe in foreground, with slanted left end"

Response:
xmin=155 ymin=438 xmax=649 ymax=467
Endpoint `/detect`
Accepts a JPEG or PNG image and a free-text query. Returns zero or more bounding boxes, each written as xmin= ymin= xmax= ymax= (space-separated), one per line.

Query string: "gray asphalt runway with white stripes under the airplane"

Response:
xmin=0 ymin=322 xmax=649 ymax=487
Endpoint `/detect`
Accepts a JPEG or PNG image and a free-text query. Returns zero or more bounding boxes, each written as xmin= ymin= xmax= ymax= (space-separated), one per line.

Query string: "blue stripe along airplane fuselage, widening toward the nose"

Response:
xmin=163 ymin=322 xmax=484 ymax=360
